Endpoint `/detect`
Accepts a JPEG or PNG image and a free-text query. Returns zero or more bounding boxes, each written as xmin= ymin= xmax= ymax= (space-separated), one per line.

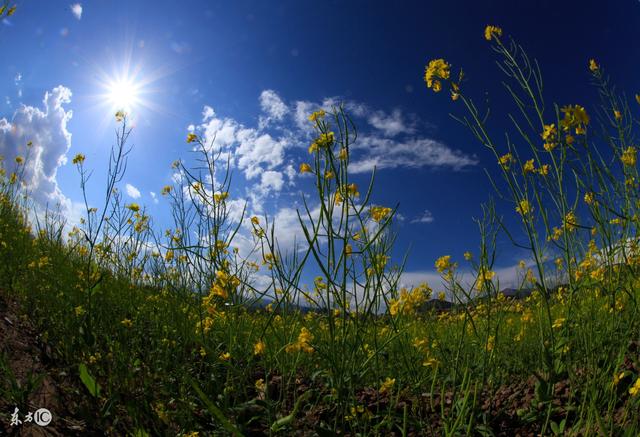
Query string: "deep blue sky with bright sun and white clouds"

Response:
xmin=0 ymin=0 xmax=640 ymax=292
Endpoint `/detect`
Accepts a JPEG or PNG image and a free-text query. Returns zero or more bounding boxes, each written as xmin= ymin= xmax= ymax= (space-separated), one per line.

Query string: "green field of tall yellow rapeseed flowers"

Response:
xmin=0 ymin=26 xmax=640 ymax=436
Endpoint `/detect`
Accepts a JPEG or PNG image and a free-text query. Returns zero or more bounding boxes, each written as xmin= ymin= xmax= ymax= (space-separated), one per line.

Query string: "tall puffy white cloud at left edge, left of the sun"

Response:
xmin=0 ymin=86 xmax=72 ymax=208
